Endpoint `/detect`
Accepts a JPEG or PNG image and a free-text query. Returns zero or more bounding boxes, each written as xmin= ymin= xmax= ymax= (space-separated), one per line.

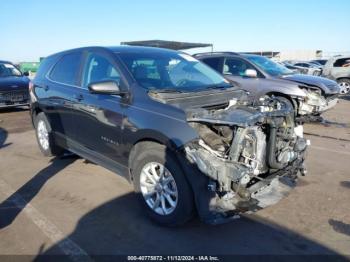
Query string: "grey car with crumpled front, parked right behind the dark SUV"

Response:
xmin=195 ymin=52 xmax=340 ymax=121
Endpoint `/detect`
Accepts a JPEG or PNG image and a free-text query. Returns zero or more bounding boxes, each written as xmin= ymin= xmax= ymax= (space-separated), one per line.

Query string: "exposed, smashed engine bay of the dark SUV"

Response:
xmin=149 ymin=88 xmax=309 ymax=223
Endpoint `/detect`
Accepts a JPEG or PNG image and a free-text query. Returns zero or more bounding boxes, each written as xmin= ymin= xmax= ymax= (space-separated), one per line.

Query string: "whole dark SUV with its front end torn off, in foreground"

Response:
xmin=30 ymin=46 xmax=308 ymax=225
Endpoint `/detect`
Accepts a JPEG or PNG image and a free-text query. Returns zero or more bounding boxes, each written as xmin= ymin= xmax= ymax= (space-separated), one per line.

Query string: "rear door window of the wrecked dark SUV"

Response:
xmin=50 ymin=52 xmax=81 ymax=85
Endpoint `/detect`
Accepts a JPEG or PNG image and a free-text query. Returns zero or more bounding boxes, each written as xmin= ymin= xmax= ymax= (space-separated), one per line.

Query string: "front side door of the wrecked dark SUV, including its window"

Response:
xmin=69 ymin=51 xmax=126 ymax=162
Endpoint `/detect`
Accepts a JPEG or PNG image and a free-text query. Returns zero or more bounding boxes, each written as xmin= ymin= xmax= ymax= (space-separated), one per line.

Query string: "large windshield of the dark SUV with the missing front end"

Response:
xmin=119 ymin=52 xmax=231 ymax=92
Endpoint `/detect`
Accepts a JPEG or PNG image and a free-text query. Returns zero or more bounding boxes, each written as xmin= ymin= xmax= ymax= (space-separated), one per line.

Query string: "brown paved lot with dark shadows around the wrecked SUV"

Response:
xmin=0 ymin=99 xmax=350 ymax=260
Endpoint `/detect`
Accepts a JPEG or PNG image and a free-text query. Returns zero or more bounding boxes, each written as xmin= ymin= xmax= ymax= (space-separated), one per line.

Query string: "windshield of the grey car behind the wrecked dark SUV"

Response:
xmin=246 ymin=56 xmax=294 ymax=76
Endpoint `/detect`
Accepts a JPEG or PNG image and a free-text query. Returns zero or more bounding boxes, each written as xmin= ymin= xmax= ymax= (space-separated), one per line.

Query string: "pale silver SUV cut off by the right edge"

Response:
xmin=322 ymin=56 xmax=350 ymax=95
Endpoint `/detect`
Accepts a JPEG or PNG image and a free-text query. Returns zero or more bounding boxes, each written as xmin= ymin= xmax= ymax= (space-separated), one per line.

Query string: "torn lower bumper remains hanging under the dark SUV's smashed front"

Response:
xmin=185 ymin=144 xmax=306 ymax=224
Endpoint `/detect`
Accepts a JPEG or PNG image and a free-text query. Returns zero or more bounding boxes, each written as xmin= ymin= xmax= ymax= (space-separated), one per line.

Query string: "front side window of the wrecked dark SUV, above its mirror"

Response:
xmin=83 ymin=54 xmax=120 ymax=87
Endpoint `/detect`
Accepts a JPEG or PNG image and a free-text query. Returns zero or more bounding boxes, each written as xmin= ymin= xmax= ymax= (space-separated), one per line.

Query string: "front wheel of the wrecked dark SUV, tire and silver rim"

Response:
xmin=131 ymin=142 xmax=194 ymax=226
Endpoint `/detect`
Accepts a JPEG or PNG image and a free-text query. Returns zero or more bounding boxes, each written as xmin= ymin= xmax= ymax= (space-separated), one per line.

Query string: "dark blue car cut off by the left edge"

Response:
xmin=0 ymin=61 xmax=29 ymax=108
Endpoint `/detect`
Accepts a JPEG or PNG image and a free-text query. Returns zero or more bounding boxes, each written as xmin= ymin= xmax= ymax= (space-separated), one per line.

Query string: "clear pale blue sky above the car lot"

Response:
xmin=0 ymin=0 xmax=350 ymax=62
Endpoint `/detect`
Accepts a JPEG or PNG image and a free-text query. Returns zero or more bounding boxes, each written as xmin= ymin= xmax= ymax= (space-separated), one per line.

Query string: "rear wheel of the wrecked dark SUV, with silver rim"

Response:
xmin=34 ymin=112 xmax=64 ymax=157
